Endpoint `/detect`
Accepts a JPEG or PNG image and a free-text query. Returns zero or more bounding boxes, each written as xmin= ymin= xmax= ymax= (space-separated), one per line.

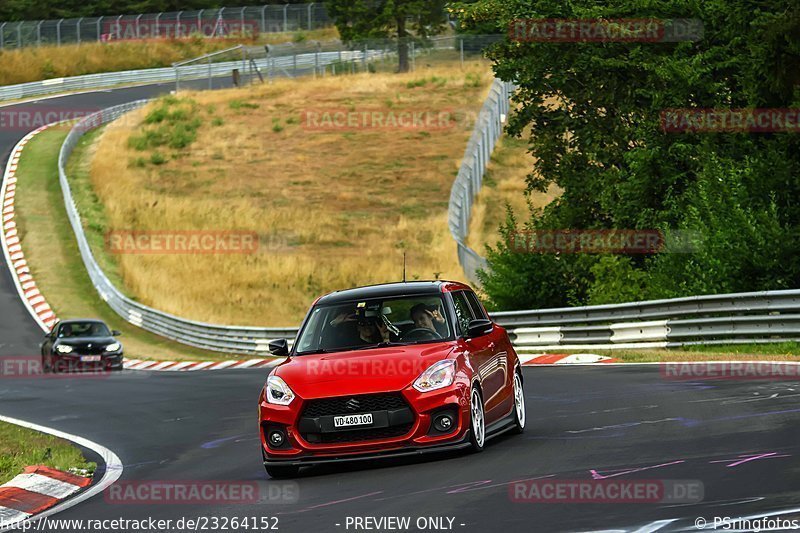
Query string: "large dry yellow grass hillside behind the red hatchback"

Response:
xmin=86 ymin=62 xmax=492 ymax=326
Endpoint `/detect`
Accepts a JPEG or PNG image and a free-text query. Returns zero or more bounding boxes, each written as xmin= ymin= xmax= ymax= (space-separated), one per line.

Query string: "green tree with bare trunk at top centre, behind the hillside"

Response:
xmin=326 ymin=0 xmax=447 ymax=72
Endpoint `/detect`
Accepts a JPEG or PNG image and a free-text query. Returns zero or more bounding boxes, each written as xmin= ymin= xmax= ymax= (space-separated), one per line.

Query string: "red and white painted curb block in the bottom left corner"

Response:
xmin=0 ymin=466 xmax=92 ymax=524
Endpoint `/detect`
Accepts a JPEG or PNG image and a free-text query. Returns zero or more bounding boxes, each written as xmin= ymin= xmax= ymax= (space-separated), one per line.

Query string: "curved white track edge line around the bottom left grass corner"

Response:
xmin=0 ymin=415 xmax=123 ymax=532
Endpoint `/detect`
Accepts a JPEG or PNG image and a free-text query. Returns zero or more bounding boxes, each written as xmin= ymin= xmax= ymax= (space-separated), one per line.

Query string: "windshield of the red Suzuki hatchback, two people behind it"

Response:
xmin=296 ymin=295 xmax=452 ymax=355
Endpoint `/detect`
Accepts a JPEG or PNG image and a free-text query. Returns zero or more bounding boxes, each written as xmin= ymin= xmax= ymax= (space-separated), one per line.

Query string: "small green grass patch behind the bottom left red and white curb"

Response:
xmin=0 ymin=422 xmax=97 ymax=484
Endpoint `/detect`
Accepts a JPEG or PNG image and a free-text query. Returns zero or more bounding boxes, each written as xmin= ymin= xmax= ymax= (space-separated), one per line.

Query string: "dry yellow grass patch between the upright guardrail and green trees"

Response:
xmin=467 ymin=128 xmax=561 ymax=253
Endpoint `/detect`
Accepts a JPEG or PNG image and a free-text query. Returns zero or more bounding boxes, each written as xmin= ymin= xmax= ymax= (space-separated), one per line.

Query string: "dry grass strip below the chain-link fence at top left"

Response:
xmin=0 ymin=28 xmax=338 ymax=85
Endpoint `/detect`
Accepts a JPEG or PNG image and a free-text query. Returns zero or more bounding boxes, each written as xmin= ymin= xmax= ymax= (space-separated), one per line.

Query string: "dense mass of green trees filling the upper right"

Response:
xmin=454 ymin=0 xmax=800 ymax=308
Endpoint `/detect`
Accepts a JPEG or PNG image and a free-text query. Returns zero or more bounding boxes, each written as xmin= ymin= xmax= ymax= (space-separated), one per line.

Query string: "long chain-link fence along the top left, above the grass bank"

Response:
xmin=0 ymin=2 xmax=332 ymax=49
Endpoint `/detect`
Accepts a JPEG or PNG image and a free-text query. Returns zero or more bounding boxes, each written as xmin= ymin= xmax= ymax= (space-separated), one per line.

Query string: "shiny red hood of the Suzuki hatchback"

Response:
xmin=275 ymin=342 xmax=456 ymax=399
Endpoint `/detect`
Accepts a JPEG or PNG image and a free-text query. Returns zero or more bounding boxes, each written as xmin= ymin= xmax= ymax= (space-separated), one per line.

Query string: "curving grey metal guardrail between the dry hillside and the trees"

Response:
xmin=448 ymin=79 xmax=514 ymax=283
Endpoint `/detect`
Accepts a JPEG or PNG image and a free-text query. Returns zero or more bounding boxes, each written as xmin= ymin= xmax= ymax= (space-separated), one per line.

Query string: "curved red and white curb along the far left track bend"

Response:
xmin=0 ymin=124 xmax=57 ymax=332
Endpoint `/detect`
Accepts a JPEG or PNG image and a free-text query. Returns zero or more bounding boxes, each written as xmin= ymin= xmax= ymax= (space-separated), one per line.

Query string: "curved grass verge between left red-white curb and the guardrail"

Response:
xmin=10 ymin=127 xmax=241 ymax=361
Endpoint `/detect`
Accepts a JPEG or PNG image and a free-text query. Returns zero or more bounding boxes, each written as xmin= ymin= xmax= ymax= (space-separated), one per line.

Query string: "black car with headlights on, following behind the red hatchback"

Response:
xmin=41 ymin=319 xmax=122 ymax=372
